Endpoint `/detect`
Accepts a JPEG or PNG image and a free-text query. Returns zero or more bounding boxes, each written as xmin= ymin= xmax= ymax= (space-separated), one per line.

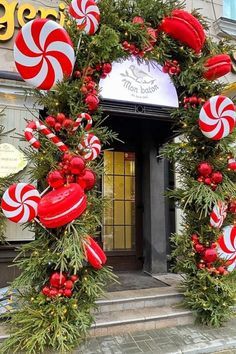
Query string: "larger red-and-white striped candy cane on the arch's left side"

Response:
xmin=25 ymin=120 xmax=69 ymax=152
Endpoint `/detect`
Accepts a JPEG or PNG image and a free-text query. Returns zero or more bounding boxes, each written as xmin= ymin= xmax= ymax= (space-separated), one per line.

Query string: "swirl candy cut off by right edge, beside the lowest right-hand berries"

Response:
xmin=217 ymin=225 xmax=236 ymax=272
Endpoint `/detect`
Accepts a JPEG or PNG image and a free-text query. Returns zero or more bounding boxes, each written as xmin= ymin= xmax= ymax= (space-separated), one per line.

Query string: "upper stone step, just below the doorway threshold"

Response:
xmin=97 ymin=287 xmax=183 ymax=313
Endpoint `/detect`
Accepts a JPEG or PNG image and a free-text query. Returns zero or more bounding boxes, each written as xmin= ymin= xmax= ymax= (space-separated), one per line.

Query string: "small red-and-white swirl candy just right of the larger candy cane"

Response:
xmin=78 ymin=134 xmax=102 ymax=161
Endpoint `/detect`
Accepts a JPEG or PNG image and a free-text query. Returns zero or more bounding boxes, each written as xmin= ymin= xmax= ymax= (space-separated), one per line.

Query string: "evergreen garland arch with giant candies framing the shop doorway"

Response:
xmin=1 ymin=0 xmax=236 ymax=353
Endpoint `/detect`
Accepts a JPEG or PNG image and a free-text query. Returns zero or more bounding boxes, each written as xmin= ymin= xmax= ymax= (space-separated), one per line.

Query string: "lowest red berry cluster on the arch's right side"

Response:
xmin=191 ymin=234 xmax=229 ymax=275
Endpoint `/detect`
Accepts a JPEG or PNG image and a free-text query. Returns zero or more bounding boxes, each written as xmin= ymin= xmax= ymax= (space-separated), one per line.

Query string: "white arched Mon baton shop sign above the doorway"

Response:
xmin=99 ymin=57 xmax=179 ymax=108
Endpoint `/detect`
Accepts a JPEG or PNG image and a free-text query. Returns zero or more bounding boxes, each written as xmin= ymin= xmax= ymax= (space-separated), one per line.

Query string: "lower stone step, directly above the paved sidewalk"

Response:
xmin=90 ymin=306 xmax=194 ymax=337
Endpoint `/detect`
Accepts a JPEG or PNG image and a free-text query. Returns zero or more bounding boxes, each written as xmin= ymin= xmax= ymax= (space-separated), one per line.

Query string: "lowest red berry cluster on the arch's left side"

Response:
xmin=42 ymin=272 xmax=79 ymax=298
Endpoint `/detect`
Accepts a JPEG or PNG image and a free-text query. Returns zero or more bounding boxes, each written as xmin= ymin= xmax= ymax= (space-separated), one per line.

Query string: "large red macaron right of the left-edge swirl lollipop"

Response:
xmin=38 ymin=183 xmax=87 ymax=229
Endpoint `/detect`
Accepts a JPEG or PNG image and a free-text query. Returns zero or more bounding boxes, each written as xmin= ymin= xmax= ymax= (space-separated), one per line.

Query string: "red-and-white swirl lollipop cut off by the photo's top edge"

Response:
xmin=69 ymin=0 xmax=100 ymax=35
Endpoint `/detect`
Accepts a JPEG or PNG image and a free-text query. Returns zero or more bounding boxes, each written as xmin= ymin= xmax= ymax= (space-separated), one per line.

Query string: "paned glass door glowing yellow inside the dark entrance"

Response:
xmin=102 ymin=150 xmax=142 ymax=270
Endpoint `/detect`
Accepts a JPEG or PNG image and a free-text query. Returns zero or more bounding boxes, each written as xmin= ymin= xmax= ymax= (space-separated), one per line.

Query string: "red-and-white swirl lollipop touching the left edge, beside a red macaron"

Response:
xmin=1 ymin=183 xmax=41 ymax=224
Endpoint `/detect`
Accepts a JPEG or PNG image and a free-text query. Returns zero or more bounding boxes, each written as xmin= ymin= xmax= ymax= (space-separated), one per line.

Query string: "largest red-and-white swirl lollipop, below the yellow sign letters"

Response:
xmin=14 ymin=19 xmax=75 ymax=90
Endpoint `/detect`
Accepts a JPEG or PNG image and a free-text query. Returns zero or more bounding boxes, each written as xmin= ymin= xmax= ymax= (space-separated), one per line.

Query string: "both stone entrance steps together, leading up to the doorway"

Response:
xmin=90 ymin=287 xmax=194 ymax=337
